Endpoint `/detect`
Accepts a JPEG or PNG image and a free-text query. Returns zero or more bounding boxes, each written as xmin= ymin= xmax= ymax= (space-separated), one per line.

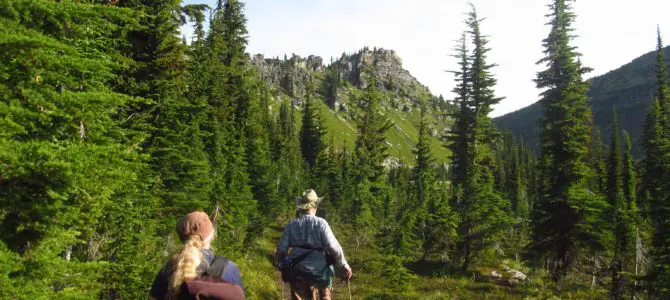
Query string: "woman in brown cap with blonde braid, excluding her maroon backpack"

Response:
xmin=150 ymin=211 xmax=243 ymax=299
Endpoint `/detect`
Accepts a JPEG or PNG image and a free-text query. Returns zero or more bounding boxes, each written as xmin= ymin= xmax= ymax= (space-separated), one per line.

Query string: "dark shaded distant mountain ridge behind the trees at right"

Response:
xmin=494 ymin=46 xmax=670 ymax=157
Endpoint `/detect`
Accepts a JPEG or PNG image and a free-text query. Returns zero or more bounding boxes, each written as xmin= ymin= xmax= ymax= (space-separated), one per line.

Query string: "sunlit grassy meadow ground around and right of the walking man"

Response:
xmin=238 ymin=225 xmax=607 ymax=299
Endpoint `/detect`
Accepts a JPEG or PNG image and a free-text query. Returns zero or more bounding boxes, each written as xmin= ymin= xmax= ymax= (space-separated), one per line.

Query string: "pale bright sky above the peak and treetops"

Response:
xmin=184 ymin=0 xmax=670 ymax=116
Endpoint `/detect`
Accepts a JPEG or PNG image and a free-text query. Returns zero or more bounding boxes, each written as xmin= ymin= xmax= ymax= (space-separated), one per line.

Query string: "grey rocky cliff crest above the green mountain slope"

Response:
xmin=252 ymin=47 xmax=443 ymax=111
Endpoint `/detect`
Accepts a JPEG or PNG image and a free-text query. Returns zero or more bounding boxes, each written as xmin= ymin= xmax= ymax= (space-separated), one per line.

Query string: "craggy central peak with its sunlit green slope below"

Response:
xmin=251 ymin=47 xmax=453 ymax=164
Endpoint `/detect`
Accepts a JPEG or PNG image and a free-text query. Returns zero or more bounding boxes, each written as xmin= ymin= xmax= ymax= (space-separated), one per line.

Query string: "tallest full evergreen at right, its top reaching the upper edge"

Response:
xmin=531 ymin=0 xmax=606 ymax=280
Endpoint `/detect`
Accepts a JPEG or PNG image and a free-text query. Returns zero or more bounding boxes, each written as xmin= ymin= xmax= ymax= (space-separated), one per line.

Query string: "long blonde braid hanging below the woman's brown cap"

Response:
xmin=168 ymin=235 xmax=205 ymax=297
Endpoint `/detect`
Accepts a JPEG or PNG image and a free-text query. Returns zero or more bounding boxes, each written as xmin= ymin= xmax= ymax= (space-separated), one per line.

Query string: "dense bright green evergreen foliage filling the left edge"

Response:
xmin=0 ymin=0 xmax=159 ymax=299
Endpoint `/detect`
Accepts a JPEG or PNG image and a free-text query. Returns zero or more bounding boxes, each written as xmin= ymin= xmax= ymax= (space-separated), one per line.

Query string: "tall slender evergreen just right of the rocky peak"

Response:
xmin=450 ymin=6 xmax=511 ymax=270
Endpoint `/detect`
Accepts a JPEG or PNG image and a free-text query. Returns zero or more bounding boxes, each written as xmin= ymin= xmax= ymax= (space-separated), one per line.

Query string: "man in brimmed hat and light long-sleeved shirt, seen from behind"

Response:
xmin=275 ymin=189 xmax=352 ymax=300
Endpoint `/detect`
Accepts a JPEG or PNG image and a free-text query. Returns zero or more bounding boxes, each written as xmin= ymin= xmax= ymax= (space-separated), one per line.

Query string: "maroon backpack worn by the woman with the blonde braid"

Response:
xmin=179 ymin=256 xmax=244 ymax=300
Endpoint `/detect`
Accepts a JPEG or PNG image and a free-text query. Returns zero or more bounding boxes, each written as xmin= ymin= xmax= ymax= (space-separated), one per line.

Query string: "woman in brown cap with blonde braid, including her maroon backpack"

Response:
xmin=150 ymin=211 xmax=244 ymax=300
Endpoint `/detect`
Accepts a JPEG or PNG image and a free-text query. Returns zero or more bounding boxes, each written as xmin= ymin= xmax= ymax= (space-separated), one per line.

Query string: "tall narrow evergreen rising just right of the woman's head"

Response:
xmin=203 ymin=0 xmax=258 ymax=253
